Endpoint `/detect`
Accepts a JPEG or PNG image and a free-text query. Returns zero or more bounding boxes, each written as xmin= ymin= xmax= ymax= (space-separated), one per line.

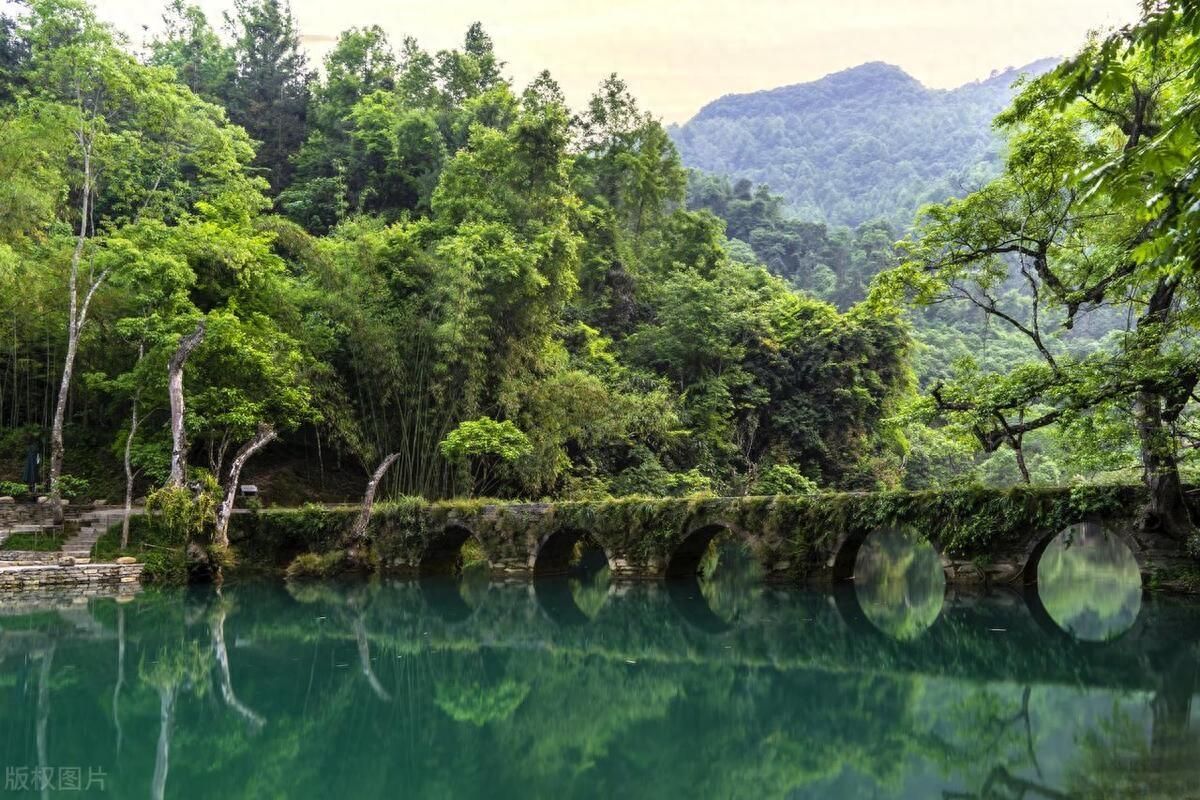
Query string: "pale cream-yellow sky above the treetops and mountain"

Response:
xmin=88 ymin=0 xmax=1138 ymax=122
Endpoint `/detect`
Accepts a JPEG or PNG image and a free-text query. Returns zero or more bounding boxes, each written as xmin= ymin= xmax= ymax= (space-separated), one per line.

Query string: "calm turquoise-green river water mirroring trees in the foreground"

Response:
xmin=0 ymin=537 xmax=1200 ymax=800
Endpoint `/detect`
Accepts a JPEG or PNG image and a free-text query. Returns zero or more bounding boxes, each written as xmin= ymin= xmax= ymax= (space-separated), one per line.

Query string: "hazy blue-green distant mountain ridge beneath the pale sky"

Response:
xmin=671 ymin=59 xmax=1058 ymax=227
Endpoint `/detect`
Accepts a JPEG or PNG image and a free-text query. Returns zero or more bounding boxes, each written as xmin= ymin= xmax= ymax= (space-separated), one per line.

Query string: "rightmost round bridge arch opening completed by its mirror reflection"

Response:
xmin=1038 ymin=523 xmax=1141 ymax=642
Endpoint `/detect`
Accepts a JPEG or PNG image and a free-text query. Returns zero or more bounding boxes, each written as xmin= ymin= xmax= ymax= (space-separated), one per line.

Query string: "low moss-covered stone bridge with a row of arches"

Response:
xmin=235 ymin=487 xmax=1195 ymax=588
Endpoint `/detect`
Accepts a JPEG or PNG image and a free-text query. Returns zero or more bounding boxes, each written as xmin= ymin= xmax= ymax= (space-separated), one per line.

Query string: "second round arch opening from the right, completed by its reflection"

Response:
xmin=854 ymin=528 xmax=946 ymax=640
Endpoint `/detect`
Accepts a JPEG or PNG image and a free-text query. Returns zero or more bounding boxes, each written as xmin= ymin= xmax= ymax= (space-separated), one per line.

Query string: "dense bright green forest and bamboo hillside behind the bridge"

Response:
xmin=0 ymin=0 xmax=908 ymax=513
